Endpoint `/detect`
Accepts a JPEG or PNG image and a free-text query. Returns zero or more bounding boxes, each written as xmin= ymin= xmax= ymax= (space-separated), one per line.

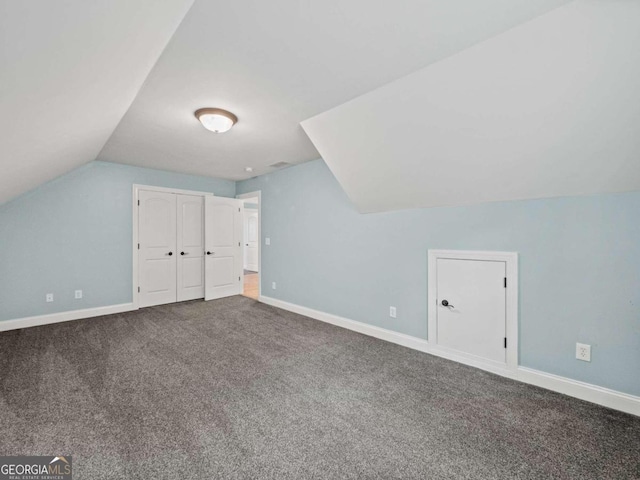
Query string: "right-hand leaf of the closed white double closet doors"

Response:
xmin=176 ymin=195 xmax=204 ymax=302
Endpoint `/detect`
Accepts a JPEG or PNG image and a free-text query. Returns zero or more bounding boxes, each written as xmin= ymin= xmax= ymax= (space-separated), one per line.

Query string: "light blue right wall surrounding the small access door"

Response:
xmin=237 ymin=160 xmax=640 ymax=395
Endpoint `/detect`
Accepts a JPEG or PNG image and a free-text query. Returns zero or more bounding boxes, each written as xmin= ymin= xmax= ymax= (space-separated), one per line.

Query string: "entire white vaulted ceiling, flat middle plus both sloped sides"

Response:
xmin=0 ymin=0 xmax=640 ymax=211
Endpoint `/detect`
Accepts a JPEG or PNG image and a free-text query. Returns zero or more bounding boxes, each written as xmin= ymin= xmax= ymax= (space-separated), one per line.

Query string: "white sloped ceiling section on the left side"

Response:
xmin=0 ymin=0 xmax=193 ymax=203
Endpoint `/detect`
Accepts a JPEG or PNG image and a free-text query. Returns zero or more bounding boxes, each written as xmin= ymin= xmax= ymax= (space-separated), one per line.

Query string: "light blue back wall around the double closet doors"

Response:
xmin=0 ymin=162 xmax=235 ymax=320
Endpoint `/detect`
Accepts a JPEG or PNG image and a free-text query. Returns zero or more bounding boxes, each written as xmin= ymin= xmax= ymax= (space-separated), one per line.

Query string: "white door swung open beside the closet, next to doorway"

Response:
xmin=204 ymin=196 xmax=243 ymax=300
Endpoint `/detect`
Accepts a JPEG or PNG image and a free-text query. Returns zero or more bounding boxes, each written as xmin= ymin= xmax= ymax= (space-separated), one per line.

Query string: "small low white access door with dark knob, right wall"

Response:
xmin=436 ymin=258 xmax=506 ymax=363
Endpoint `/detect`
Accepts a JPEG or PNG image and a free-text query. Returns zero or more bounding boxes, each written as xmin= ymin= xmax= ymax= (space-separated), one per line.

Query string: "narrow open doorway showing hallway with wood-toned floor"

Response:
xmin=237 ymin=192 xmax=261 ymax=300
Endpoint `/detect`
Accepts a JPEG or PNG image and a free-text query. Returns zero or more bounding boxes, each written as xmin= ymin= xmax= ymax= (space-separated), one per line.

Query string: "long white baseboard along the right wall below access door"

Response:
xmin=259 ymin=295 xmax=640 ymax=416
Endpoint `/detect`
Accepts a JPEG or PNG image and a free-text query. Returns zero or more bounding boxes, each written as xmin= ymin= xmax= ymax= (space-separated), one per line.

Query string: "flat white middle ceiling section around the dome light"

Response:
xmin=97 ymin=0 xmax=567 ymax=180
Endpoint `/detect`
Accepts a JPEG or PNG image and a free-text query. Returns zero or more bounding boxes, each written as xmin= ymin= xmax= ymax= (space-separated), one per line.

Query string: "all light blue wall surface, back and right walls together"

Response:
xmin=0 ymin=156 xmax=640 ymax=395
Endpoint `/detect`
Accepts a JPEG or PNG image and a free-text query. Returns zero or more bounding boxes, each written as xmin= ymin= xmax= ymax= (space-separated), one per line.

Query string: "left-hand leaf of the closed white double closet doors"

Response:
xmin=138 ymin=190 xmax=177 ymax=307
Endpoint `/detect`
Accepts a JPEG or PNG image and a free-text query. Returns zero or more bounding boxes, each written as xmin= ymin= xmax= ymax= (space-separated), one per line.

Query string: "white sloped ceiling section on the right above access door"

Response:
xmin=302 ymin=0 xmax=640 ymax=212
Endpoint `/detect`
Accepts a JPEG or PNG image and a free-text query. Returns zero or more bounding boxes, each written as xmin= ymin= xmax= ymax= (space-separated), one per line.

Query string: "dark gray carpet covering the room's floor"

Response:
xmin=0 ymin=297 xmax=640 ymax=480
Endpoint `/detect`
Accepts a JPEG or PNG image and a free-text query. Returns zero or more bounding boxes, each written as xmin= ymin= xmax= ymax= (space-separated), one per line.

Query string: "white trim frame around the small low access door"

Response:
xmin=427 ymin=250 xmax=520 ymax=371
